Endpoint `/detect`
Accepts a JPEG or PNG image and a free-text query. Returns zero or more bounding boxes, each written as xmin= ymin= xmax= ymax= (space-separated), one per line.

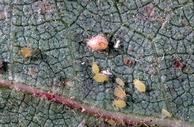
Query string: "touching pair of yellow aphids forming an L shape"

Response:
xmin=92 ymin=62 xmax=109 ymax=83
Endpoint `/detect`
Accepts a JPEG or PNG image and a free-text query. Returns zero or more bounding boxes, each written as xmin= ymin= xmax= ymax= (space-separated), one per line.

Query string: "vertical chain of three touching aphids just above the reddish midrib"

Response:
xmin=113 ymin=78 xmax=127 ymax=109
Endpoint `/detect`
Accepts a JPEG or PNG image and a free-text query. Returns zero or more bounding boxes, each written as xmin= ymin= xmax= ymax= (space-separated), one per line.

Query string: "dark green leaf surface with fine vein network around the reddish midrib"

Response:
xmin=0 ymin=0 xmax=194 ymax=127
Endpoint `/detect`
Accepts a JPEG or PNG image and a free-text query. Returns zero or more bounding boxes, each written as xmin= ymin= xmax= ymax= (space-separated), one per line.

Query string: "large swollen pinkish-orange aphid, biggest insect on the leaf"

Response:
xmin=87 ymin=34 xmax=108 ymax=51
